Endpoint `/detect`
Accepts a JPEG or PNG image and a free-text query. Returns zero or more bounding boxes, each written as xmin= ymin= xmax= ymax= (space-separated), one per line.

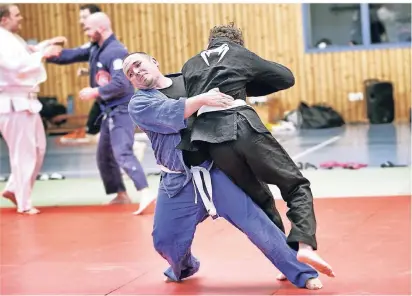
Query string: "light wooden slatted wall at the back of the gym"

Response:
xmin=20 ymin=3 xmax=411 ymax=121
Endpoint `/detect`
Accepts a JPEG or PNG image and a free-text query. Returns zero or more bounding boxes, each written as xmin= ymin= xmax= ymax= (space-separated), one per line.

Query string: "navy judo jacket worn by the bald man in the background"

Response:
xmin=47 ymin=35 xmax=134 ymax=110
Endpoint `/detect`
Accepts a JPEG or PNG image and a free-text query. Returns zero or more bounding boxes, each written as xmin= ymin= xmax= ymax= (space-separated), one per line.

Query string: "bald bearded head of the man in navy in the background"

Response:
xmin=84 ymin=12 xmax=113 ymax=45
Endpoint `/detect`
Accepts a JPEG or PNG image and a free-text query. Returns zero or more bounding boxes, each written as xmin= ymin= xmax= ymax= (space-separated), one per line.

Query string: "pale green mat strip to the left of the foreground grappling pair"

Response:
xmin=0 ymin=176 xmax=160 ymax=208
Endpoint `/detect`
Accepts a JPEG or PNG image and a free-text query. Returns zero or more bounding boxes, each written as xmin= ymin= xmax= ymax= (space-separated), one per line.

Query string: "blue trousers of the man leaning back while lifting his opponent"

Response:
xmin=153 ymin=163 xmax=318 ymax=288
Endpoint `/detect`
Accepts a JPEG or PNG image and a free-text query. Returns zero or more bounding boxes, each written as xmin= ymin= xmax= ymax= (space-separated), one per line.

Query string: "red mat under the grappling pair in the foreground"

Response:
xmin=0 ymin=197 xmax=411 ymax=295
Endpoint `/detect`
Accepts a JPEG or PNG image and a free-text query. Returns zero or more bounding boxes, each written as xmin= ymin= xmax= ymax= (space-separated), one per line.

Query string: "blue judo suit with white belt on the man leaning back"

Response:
xmin=129 ymin=90 xmax=318 ymax=288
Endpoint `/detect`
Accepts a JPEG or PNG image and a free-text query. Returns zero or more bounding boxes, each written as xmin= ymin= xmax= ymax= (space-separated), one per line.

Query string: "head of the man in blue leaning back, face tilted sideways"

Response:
xmin=126 ymin=55 xmax=161 ymax=89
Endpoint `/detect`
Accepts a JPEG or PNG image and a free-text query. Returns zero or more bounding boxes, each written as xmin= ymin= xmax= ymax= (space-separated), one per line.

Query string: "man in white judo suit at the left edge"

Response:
xmin=0 ymin=4 xmax=63 ymax=214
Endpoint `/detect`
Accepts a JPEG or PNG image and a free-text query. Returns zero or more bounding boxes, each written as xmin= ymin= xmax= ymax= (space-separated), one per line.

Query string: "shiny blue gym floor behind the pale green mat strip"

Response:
xmin=0 ymin=124 xmax=411 ymax=178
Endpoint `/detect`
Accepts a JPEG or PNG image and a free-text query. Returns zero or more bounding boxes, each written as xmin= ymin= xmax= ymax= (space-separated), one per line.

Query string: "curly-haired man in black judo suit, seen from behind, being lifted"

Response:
xmin=180 ymin=24 xmax=334 ymax=276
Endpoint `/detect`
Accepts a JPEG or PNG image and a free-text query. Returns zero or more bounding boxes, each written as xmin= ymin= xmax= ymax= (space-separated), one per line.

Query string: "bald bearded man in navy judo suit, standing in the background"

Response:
xmin=47 ymin=12 xmax=154 ymax=210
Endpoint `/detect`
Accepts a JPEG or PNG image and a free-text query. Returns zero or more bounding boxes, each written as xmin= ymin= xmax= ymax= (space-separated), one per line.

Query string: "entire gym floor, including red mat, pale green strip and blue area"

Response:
xmin=0 ymin=124 xmax=411 ymax=295
